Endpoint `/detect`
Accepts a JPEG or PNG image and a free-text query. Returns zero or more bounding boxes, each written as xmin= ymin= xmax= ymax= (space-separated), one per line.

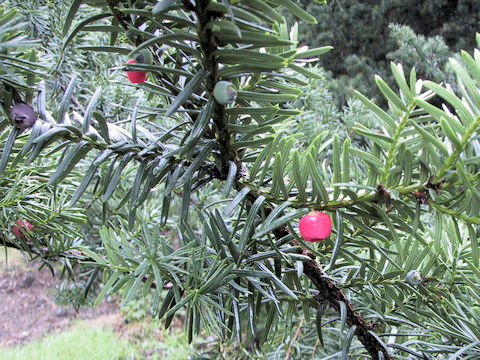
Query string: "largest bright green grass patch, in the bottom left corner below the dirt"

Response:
xmin=0 ymin=324 xmax=134 ymax=360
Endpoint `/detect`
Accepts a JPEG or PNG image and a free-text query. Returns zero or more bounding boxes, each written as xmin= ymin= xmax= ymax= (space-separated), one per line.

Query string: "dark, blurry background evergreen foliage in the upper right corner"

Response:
xmin=299 ymin=0 xmax=480 ymax=105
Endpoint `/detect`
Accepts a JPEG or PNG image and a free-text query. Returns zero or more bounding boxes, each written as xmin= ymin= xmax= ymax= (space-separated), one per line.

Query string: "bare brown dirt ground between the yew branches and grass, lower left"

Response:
xmin=0 ymin=248 xmax=122 ymax=348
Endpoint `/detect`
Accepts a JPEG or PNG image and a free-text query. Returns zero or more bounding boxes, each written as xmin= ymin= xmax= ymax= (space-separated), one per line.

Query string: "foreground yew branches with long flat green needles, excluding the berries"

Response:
xmin=0 ymin=0 xmax=480 ymax=359
